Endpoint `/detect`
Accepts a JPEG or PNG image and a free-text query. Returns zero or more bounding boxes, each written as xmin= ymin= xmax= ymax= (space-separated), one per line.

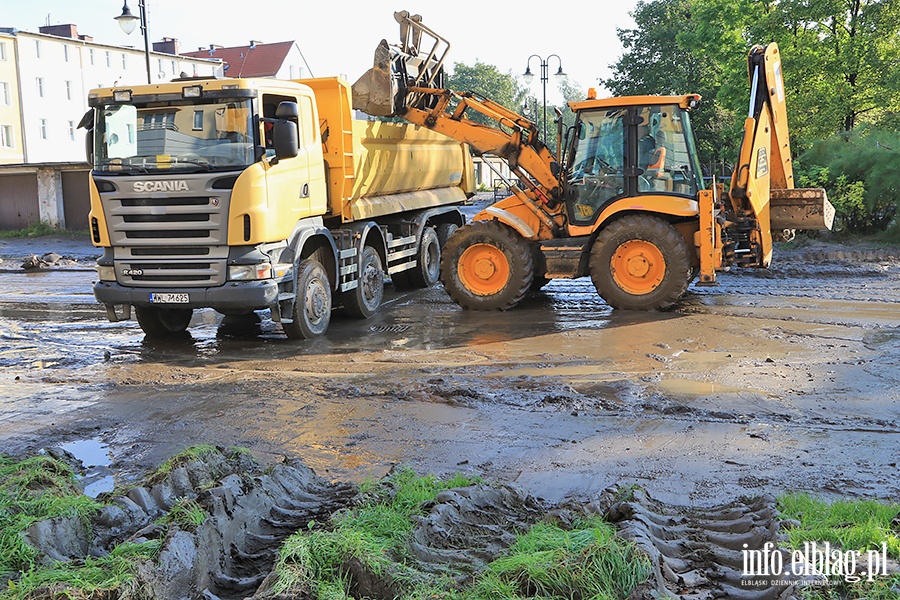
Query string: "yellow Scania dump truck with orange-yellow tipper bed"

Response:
xmin=82 ymin=78 xmax=473 ymax=338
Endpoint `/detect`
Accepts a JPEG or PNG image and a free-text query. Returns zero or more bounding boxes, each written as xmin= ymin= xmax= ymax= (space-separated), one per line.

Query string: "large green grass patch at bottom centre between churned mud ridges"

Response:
xmin=269 ymin=470 xmax=650 ymax=600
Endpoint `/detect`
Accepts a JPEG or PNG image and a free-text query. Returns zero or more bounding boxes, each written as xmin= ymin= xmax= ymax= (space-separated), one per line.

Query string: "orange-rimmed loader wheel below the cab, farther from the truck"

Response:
xmin=590 ymin=215 xmax=691 ymax=310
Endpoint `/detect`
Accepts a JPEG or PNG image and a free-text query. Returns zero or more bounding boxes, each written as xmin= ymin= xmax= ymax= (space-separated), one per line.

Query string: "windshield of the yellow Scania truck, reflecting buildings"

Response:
xmin=94 ymin=98 xmax=257 ymax=173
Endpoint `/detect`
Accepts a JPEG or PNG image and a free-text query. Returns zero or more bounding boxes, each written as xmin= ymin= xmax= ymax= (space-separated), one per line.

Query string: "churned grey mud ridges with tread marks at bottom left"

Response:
xmin=25 ymin=448 xmax=358 ymax=599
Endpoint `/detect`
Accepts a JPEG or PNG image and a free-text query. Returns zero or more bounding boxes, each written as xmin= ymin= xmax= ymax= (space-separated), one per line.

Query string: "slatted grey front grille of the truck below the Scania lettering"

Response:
xmin=102 ymin=182 xmax=230 ymax=288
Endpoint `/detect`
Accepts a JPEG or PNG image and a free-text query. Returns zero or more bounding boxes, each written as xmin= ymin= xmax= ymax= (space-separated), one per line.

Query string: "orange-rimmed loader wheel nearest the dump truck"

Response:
xmin=441 ymin=221 xmax=534 ymax=310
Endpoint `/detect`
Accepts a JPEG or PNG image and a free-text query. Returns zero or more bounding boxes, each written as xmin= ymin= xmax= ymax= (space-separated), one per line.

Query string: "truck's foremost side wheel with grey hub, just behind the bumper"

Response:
xmin=282 ymin=259 xmax=331 ymax=340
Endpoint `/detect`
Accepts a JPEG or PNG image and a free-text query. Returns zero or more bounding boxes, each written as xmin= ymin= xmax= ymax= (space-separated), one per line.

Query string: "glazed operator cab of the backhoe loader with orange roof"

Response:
xmin=566 ymin=97 xmax=702 ymax=226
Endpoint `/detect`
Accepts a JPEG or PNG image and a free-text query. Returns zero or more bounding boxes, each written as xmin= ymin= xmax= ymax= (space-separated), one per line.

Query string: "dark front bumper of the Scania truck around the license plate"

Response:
xmin=94 ymin=279 xmax=278 ymax=313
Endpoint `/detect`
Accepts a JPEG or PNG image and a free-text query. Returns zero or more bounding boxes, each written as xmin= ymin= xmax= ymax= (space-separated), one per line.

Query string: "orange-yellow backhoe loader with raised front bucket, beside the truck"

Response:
xmin=353 ymin=11 xmax=834 ymax=310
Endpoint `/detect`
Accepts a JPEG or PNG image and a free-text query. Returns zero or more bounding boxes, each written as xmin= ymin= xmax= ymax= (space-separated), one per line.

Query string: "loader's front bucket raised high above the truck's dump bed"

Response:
xmin=352 ymin=11 xmax=450 ymax=117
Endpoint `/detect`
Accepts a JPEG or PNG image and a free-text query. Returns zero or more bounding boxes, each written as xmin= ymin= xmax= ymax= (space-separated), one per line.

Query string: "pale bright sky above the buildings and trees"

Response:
xmin=0 ymin=0 xmax=637 ymax=103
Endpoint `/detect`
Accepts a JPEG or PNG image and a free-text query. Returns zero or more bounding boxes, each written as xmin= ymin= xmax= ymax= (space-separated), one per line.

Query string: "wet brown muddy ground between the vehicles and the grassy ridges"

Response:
xmin=0 ymin=221 xmax=900 ymax=506
